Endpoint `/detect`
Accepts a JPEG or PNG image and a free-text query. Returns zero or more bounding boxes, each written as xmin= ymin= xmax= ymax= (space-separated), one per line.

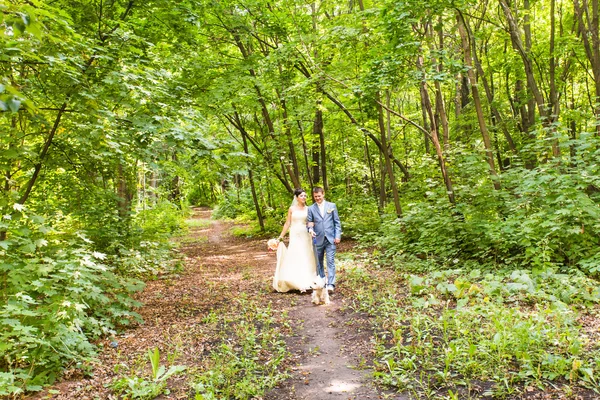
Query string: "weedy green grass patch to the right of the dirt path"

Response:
xmin=344 ymin=258 xmax=600 ymax=399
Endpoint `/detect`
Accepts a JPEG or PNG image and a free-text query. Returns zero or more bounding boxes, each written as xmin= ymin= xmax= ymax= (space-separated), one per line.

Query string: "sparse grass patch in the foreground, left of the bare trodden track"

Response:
xmin=110 ymin=293 xmax=290 ymax=400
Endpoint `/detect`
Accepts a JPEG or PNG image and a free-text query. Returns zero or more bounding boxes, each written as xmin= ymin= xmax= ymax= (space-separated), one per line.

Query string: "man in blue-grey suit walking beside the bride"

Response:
xmin=306 ymin=187 xmax=342 ymax=292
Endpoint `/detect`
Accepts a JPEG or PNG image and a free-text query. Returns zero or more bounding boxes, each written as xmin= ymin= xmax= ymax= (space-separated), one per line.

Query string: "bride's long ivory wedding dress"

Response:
xmin=273 ymin=207 xmax=317 ymax=292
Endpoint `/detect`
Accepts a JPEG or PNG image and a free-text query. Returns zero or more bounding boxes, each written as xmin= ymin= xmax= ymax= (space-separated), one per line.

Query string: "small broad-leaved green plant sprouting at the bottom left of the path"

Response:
xmin=110 ymin=347 xmax=186 ymax=400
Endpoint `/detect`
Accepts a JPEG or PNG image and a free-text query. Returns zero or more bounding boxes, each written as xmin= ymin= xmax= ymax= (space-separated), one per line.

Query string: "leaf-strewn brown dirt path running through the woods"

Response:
xmin=31 ymin=209 xmax=390 ymax=400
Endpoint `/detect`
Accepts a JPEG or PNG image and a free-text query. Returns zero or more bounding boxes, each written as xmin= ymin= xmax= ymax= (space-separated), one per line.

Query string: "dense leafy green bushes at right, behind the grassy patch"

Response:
xmin=374 ymin=138 xmax=600 ymax=274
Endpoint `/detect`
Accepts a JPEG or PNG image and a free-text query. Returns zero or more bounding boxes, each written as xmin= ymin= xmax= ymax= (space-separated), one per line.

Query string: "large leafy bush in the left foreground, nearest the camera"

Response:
xmin=0 ymin=205 xmax=143 ymax=394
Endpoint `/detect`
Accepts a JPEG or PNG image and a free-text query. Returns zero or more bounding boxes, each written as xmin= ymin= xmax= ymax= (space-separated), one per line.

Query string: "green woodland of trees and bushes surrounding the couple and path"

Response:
xmin=0 ymin=0 xmax=600 ymax=394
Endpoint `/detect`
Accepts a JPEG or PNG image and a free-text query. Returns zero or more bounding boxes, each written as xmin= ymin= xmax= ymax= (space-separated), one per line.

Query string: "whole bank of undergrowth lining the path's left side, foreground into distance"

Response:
xmin=0 ymin=204 xmax=183 ymax=397
